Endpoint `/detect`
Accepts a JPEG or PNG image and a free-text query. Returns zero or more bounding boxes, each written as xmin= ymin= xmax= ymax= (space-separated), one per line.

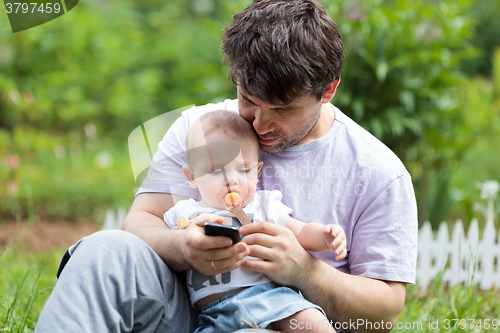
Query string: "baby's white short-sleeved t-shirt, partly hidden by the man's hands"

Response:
xmin=163 ymin=191 xmax=292 ymax=306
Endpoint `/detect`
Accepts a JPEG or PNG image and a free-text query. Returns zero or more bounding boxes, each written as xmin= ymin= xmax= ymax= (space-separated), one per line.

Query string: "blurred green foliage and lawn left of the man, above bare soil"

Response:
xmin=0 ymin=0 xmax=250 ymax=221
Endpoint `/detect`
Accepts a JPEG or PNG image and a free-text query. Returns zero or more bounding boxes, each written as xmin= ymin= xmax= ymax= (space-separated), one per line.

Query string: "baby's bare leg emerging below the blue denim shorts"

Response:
xmin=272 ymin=308 xmax=335 ymax=333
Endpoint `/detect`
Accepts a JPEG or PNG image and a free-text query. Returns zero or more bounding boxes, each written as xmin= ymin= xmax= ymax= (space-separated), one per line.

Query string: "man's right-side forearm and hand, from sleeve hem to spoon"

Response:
xmin=240 ymin=222 xmax=406 ymax=332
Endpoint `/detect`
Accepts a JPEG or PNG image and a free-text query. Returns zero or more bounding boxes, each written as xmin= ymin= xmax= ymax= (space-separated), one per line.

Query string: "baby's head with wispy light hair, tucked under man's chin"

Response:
xmin=182 ymin=110 xmax=262 ymax=209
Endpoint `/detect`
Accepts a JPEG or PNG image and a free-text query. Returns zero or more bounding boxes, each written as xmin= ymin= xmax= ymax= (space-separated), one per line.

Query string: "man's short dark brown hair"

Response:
xmin=222 ymin=0 xmax=344 ymax=104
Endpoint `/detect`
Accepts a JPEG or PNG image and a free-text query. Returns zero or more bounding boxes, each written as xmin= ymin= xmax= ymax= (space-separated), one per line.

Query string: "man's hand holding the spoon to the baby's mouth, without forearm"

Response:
xmin=240 ymin=222 xmax=313 ymax=287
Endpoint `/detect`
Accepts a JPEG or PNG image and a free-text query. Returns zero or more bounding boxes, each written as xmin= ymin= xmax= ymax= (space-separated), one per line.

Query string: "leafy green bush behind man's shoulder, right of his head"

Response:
xmin=318 ymin=0 xmax=498 ymax=224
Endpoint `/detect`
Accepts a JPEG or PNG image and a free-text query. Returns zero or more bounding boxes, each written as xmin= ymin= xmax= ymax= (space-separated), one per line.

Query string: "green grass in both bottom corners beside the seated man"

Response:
xmin=0 ymin=235 xmax=500 ymax=333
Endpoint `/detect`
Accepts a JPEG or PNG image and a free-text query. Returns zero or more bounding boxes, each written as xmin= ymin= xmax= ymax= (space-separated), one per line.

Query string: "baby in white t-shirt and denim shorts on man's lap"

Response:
xmin=164 ymin=111 xmax=346 ymax=332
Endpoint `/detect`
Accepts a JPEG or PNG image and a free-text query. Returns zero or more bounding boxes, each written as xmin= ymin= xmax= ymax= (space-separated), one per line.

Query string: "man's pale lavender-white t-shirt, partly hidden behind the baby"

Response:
xmin=138 ymin=100 xmax=418 ymax=283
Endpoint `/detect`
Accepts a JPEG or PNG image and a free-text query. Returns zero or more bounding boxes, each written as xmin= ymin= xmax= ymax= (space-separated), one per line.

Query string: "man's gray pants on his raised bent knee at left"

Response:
xmin=35 ymin=230 xmax=197 ymax=333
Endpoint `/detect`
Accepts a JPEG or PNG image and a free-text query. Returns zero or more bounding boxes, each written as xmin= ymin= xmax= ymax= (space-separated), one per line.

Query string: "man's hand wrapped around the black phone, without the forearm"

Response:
xmin=181 ymin=214 xmax=250 ymax=276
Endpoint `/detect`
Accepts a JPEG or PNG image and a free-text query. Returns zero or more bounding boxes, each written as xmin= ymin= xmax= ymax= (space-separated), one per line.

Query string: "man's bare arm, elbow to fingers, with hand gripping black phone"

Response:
xmin=122 ymin=193 xmax=248 ymax=275
